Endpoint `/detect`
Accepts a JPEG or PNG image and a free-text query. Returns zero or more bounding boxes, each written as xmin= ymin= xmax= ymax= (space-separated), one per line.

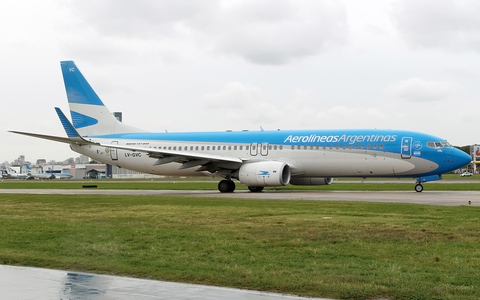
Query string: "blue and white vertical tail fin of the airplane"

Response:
xmin=60 ymin=61 xmax=143 ymax=137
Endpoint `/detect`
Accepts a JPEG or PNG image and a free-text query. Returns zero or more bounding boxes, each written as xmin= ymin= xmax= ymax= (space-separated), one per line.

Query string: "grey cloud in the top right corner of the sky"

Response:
xmin=392 ymin=0 xmax=480 ymax=52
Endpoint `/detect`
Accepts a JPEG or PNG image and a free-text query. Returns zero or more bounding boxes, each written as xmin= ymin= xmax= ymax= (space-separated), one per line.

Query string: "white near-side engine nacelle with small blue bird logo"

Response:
xmin=238 ymin=161 xmax=291 ymax=186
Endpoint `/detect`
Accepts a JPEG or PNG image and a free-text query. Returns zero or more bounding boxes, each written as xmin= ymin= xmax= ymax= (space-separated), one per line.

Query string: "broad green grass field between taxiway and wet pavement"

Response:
xmin=0 ymin=194 xmax=480 ymax=299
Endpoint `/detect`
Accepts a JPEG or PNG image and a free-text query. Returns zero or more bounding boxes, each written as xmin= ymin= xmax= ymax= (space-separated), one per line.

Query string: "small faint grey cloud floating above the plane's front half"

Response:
xmin=384 ymin=78 xmax=460 ymax=103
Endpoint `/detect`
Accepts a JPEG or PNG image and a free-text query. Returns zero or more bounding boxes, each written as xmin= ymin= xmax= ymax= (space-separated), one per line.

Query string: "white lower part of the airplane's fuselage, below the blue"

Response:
xmin=72 ymin=140 xmax=438 ymax=177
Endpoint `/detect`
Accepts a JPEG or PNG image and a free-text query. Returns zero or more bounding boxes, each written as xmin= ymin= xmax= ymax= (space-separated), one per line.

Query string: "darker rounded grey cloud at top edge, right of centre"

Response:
xmin=204 ymin=0 xmax=347 ymax=65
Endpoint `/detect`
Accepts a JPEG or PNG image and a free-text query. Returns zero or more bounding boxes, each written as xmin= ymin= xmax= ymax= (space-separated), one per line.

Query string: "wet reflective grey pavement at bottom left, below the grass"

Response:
xmin=0 ymin=265 xmax=332 ymax=300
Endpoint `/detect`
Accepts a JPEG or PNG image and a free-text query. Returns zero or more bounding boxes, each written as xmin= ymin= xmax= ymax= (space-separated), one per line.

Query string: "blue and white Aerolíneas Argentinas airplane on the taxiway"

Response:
xmin=11 ymin=61 xmax=471 ymax=193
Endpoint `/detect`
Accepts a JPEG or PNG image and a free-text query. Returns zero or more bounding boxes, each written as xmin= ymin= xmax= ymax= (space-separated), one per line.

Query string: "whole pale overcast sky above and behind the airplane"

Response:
xmin=0 ymin=0 xmax=480 ymax=162
